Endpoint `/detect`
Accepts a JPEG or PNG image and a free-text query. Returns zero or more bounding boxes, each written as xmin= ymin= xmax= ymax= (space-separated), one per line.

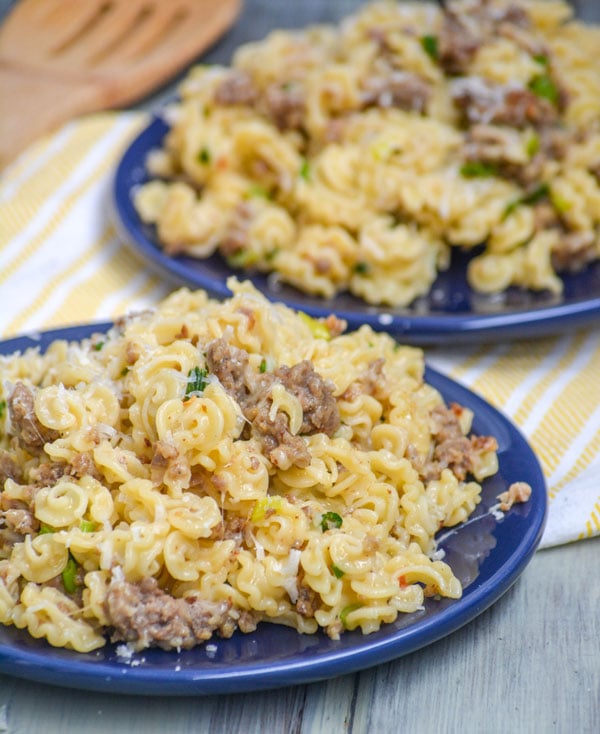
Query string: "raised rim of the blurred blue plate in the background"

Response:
xmin=109 ymin=116 xmax=600 ymax=345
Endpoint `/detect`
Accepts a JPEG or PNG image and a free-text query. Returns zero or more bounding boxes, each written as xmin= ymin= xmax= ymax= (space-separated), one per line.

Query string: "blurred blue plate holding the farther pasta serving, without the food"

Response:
xmin=112 ymin=117 xmax=600 ymax=344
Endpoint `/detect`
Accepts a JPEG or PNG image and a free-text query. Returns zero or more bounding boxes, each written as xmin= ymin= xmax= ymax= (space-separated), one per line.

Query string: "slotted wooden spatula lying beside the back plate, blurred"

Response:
xmin=0 ymin=0 xmax=241 ymax=169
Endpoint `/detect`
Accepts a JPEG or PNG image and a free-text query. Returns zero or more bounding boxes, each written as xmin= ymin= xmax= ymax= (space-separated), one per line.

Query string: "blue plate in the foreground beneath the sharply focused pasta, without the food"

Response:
xmin=0 ymin=324 xmax=546 ymax=696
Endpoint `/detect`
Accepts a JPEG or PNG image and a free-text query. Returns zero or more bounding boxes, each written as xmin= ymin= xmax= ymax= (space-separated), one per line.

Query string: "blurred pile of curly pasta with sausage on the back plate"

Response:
xmin=134 ymin=0 xmax=600 ymax=307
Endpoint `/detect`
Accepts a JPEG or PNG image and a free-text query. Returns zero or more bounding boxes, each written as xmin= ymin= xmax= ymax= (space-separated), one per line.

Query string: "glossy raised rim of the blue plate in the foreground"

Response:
xmin=0 ymin=322 xmax=548 ymax=696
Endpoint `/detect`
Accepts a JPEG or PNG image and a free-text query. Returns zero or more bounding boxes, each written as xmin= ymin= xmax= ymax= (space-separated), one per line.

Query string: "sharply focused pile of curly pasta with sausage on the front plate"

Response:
xmin=0 ymin=280 xmax=508 ymax=652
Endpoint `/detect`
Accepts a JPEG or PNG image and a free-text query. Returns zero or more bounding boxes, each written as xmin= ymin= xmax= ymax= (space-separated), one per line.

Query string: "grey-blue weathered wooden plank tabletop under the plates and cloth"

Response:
xmin=0 ymin=0 xmax=600 ymax=734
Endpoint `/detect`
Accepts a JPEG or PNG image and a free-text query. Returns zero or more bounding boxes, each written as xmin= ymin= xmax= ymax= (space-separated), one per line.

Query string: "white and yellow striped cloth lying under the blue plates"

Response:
xmin=0 ymin=113 xmax=600 ymax=547
